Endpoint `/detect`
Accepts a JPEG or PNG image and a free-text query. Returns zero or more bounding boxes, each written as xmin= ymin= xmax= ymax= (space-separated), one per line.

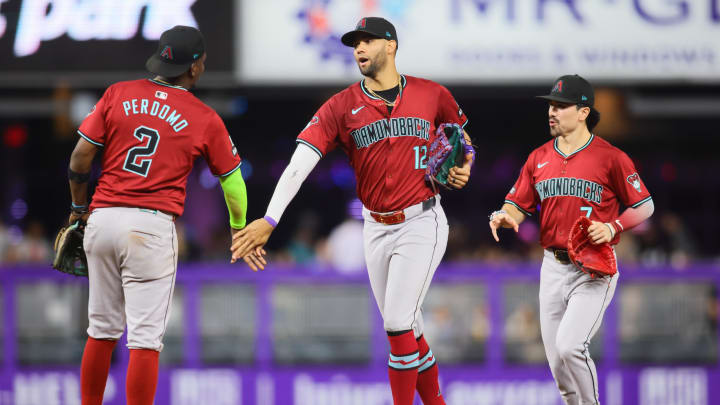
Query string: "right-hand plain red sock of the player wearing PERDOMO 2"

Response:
xmin=125 ymin=349 xmax=160 ymax=405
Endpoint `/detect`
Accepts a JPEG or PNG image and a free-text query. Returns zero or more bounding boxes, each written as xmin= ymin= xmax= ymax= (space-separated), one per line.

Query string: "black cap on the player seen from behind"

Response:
xmin=145 ymin=25 xmax=205 ymax=77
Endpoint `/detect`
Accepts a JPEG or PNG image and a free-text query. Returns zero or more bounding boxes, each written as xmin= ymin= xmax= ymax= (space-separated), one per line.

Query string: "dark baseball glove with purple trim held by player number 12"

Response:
xmin=425 ymin=124 xmax=474 ymax=189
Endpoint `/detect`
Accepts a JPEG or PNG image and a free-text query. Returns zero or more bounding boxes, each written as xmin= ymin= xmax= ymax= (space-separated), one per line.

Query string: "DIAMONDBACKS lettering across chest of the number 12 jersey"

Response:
xmin=350 ymin=117 xmax=430 ymax=149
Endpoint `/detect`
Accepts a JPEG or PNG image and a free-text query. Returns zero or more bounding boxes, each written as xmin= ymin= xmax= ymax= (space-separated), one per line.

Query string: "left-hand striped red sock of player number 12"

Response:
xmin=388 ymin=330 xmax=418 ymax=405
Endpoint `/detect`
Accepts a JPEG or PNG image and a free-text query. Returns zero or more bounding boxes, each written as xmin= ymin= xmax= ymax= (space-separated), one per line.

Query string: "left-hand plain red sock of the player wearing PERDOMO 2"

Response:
xmin=80 ymin=337 xmax=117 ymax=405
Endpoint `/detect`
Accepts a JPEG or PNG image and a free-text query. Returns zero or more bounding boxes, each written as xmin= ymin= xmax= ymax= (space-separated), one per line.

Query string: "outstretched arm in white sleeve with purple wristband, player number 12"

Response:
xmin=231 ymin=143 xmax=320 ymax=270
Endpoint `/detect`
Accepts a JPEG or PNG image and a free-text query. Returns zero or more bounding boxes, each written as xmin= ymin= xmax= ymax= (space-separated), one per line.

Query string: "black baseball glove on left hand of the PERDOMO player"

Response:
xmin=53 ymin=220 xmax=87 ymax=277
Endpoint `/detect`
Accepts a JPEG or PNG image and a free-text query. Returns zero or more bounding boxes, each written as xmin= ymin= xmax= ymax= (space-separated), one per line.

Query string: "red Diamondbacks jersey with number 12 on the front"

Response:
xmin=297 ymin=75 xmax=467 ymax=212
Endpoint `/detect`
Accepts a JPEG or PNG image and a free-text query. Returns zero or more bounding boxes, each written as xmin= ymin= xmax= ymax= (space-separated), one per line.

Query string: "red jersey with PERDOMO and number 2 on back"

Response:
xmin=78 ymin=80 xmax=240 ymax=215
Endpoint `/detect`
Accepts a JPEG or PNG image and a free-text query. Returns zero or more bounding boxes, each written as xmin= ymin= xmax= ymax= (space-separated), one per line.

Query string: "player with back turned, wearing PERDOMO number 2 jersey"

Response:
xmin=68 ymin=26 xmax=247 ymax=405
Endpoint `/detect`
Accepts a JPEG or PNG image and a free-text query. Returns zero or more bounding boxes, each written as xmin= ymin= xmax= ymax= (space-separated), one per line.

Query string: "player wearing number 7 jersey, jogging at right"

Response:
xmin=490 ymin=75 xmax=654 ymax=405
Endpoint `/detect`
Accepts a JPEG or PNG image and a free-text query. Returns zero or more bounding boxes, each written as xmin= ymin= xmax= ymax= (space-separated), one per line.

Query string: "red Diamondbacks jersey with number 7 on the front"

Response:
xmin=505 ymin=135 xmax=651 ymax=249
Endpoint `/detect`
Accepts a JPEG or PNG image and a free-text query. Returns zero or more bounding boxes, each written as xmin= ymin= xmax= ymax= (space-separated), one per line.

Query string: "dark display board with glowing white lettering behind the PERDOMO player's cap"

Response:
xmin=0 ymin=0 xmax=233 ymax=76
